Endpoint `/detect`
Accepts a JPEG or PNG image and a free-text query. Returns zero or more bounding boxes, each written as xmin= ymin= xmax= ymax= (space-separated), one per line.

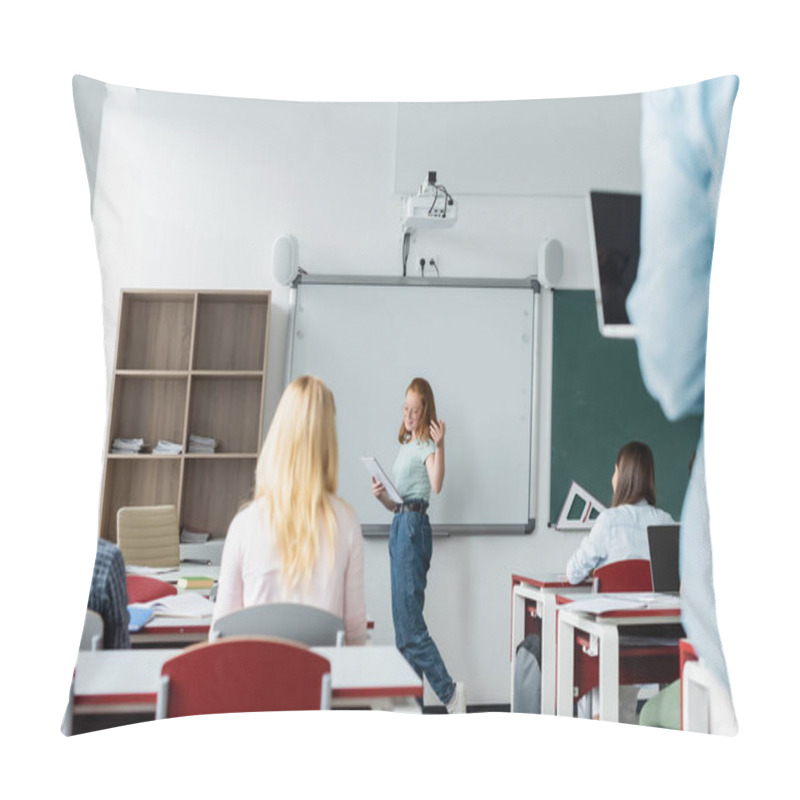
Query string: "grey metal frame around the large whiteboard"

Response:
xmin=283 ymin=274 xmax=542 ymax=536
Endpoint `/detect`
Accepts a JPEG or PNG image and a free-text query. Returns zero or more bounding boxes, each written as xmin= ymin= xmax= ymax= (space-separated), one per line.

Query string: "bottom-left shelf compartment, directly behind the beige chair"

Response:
xmin=100 ymin=456 xmax=181 ymax=542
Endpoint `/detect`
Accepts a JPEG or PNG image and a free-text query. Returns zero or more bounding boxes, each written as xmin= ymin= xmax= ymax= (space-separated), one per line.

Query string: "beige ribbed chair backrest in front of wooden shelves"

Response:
xmin=117 ymin=506 xmax=181 ymax=567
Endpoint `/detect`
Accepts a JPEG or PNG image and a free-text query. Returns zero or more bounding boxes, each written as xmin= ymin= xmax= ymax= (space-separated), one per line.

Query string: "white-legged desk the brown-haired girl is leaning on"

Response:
xmin=511 ymin=572 xmax=592 ymax=715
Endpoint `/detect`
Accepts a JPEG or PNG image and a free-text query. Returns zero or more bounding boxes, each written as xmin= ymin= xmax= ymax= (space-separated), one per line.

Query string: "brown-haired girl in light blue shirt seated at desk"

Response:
xmin=566 ymin=442 xmax=674 ymax=584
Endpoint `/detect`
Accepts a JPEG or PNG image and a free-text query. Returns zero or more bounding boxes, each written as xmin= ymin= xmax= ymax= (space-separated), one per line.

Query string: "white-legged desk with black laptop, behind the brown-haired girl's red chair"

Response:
xmin=556 ymin=592 xmax=681 ymax=722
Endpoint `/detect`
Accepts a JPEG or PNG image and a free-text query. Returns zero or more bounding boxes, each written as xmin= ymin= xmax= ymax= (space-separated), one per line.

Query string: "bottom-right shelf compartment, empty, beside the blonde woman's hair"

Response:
xmin=182 ymin=457 xmax=256 ymax=539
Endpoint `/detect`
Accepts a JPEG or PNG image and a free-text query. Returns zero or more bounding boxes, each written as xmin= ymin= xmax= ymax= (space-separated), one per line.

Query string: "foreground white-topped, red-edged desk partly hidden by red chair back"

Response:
xmin=72 ymin=645 xmax=422 ymax=715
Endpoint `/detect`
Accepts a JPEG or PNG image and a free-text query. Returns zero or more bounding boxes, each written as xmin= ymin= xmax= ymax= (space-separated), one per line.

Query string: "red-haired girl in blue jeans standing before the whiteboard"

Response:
xmin=372 ymin=378 xmax=466 ymax=714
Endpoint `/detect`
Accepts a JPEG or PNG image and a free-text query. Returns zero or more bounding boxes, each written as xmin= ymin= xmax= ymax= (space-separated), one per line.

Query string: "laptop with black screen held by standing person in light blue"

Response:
xmin=588 ymin=191 xmax=642 ymax=338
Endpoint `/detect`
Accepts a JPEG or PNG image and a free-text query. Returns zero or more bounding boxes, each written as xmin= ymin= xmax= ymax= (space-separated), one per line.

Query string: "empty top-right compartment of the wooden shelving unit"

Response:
xmin=192 ymin=292 xmax=269 ymax=371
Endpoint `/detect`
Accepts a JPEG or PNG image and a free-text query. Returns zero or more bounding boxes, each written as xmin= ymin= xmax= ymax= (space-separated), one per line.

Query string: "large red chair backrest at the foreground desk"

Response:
xmin=156 ymin=636 xmax=331 ymax=719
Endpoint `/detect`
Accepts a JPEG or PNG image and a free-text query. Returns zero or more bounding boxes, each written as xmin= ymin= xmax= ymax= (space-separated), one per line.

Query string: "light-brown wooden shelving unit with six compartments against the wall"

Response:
xmin=100 ymin=291 xmax=270 ymax=541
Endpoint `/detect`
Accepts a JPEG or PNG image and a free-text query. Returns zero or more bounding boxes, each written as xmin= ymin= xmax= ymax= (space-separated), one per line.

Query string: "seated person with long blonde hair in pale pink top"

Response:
xmin=212 ymin=376 xmax=367 ymax=644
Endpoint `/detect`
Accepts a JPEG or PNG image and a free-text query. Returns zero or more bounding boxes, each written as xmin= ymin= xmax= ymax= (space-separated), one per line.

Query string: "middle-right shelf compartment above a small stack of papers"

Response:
xmin=186 ymin=376 xmax=263 ymax=455
